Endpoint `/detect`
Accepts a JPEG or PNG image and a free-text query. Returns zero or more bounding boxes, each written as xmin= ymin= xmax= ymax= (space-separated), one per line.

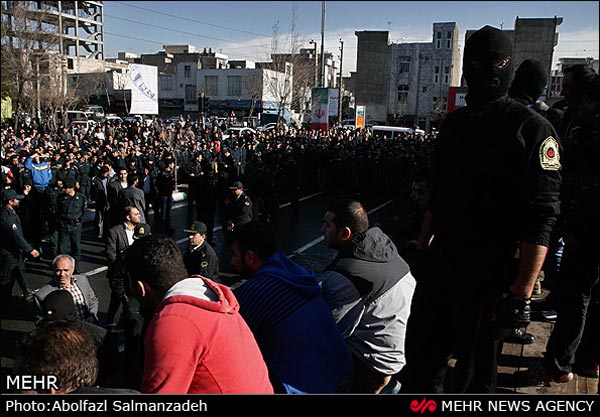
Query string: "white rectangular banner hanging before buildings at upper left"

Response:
xmin=129 ymin=64 xmax=158 ymax=114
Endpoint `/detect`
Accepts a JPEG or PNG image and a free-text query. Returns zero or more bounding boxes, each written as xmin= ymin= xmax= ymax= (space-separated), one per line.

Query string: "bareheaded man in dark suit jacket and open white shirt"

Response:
xmin=106 ymin=206 xmax=142 ymax=327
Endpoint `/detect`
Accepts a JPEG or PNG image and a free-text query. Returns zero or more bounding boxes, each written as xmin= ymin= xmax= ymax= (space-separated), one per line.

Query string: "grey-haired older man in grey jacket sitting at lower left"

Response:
xmin=33 ymin=255 xmax=99 ymax=324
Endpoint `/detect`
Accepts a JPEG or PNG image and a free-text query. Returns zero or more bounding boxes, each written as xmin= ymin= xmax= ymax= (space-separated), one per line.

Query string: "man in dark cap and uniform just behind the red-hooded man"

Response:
xmin=183 ymin=221 xmax=219 ymax=281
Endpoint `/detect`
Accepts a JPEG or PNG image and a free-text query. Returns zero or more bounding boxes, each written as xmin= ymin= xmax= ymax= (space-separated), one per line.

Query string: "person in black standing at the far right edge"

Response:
xmin=527 ymin=65 xmax=600 ymax=385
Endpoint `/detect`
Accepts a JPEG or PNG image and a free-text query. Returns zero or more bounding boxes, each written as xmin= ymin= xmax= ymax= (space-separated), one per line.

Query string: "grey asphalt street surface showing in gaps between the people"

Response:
xmin=1 ymin=187 xmax=404 ymax=374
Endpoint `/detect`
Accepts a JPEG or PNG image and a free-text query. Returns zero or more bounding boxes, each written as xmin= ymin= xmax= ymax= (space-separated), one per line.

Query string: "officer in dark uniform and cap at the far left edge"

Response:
xmin=0 ymin=189 xmax=40 ymax=308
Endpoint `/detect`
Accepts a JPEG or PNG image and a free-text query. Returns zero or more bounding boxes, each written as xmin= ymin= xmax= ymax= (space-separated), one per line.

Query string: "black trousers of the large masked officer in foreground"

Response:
xmin=398 ymin=250 xmax=506 ymax=393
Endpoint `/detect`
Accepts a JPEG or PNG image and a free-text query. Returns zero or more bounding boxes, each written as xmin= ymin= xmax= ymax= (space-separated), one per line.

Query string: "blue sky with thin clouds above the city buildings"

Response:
xmin=104 ymin=0 xmax=600 ymax=76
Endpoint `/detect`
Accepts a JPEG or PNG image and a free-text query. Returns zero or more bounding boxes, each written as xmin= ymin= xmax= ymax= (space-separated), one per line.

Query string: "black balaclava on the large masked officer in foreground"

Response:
xmin=463 ymin=26 xmax=512 ymax=107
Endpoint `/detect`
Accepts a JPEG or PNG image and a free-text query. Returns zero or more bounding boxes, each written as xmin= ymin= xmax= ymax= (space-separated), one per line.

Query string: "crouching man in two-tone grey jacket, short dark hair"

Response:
xmin=321 ymin=200 xmax=416 ymax=394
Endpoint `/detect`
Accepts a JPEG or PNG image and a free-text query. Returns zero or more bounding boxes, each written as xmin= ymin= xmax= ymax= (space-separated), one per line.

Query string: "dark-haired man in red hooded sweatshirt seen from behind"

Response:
xmin=126 ymin=235 xmax=273 ymax=394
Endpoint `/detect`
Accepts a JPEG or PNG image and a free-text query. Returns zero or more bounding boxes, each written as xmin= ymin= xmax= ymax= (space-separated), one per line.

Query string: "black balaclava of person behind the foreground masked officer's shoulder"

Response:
xmin=508 ymin=59 xmax=548 ymax=106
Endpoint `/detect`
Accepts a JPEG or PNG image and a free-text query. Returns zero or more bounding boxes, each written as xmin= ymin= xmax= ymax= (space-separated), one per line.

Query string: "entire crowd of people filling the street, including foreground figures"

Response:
xmin=1 ymin=26 xmax=600 ymax=394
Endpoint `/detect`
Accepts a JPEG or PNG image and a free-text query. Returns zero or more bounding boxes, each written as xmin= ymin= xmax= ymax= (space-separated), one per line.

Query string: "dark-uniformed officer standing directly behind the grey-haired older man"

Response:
xmin=56 ymin=178 xmax=87 ymax=270
